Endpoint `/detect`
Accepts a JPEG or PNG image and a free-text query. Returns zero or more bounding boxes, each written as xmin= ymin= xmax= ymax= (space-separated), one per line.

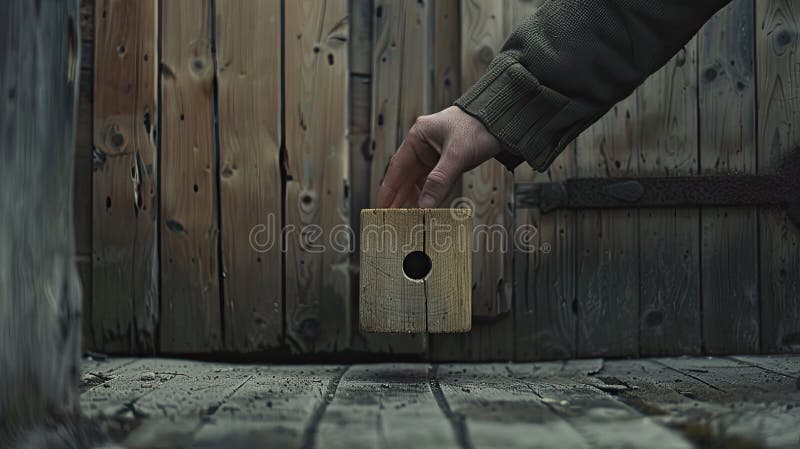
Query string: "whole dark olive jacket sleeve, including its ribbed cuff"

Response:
xmin=456 ymin=0 xmax=729 ymax=171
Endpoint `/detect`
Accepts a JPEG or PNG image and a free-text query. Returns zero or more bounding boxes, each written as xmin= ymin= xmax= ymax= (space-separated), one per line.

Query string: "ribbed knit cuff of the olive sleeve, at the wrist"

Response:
xmin=456 ymin=53 xmax=599 ymax=171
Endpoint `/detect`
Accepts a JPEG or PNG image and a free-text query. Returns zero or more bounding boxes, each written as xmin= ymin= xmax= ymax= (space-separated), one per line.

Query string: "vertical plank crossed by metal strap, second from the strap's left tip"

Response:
xmin=566 ymin=95 xmax=640 ymax=357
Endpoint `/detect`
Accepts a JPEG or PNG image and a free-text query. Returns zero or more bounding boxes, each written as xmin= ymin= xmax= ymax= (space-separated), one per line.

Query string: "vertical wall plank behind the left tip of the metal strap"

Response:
xmin=496 ymin=0 xmax=576 ymax=361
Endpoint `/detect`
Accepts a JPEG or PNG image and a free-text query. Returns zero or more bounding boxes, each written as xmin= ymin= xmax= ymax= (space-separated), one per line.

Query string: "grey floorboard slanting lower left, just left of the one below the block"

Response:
xmin=193 ymin=365 xmax=345 ymax=449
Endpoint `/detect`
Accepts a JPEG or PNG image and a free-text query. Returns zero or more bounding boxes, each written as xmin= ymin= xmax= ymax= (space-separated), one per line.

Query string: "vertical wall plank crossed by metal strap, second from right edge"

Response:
xmin=698 ymin=0 xmax=759 ymax=354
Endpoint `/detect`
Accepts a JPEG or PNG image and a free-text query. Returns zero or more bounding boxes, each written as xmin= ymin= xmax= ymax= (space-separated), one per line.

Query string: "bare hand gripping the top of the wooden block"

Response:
xmin=378 ymin=106 xmax=503 ymax=208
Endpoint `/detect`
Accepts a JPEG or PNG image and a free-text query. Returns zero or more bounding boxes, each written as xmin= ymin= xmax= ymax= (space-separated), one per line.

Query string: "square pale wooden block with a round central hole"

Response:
xmin=359 ymin=209 xmax=472 ymax=333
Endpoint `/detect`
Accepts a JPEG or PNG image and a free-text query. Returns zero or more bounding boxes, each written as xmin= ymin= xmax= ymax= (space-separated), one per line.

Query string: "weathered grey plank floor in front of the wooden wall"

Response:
xmin=82 ymin=355 xmax=800 ymax=449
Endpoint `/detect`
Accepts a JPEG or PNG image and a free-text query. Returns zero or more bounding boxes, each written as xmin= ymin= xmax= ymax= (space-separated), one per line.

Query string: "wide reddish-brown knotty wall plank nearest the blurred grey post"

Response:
xmin=91 ymin=0 xmax=159 ymax=353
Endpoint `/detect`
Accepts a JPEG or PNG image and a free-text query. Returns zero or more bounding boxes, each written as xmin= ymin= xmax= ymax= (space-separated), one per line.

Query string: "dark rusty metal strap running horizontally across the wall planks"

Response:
xmin=515 ymin=175 xmax=800 ymax=226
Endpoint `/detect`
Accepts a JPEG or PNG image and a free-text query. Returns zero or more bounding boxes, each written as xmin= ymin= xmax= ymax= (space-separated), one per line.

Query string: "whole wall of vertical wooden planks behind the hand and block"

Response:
xmin=76 ymin=0 xmax=800 ymax=360
